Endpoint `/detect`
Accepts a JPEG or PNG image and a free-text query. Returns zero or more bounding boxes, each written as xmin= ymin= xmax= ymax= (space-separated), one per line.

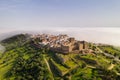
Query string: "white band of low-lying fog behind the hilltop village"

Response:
xmin=0 ymin=27 xmax=120 ymax=46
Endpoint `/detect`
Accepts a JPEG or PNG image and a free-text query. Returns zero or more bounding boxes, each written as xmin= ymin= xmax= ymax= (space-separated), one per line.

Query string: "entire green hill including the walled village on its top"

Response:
xmin=0 ymin=34 xmax=120 ymax=80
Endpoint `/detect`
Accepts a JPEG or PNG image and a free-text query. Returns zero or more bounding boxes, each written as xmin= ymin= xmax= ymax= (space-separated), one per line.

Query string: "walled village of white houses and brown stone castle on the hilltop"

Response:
xmin=31 ymin=34 xmax=91 ymax=54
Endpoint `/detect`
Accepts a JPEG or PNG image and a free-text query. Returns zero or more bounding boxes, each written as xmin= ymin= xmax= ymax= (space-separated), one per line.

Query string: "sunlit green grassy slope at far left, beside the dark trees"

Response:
xmin=0 ymin=43 xmax=51 ymax=80
